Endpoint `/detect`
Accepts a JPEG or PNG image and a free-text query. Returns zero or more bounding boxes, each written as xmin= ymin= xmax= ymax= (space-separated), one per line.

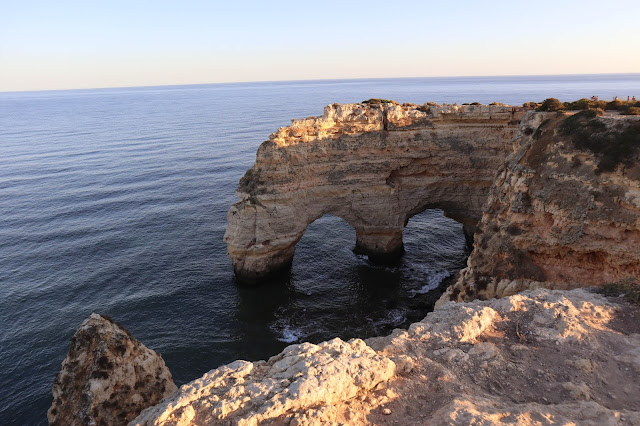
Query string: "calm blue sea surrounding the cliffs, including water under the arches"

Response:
xmin=0 ymin=74 xmax=640 ymax=425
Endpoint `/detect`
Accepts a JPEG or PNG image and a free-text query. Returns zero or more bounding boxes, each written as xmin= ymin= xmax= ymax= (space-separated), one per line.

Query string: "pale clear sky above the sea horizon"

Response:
xmin=0 ymin=0 xmax=640 ymax=92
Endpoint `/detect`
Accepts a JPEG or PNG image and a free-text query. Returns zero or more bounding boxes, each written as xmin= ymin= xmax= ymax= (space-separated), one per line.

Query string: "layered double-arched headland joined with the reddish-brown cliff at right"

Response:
xmin=225 ymin=103 xmax=640 ymax=301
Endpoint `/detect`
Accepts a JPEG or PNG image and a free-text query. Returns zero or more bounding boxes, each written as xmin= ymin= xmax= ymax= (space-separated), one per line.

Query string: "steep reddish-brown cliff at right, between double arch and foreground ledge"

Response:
xmin=441 ymin=113 xmax=640 ymax=301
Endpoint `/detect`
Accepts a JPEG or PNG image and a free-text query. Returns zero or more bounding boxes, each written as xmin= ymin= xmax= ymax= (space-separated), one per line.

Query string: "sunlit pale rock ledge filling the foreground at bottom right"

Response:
xmin=132 ymin=289 xmax=640 ymax=425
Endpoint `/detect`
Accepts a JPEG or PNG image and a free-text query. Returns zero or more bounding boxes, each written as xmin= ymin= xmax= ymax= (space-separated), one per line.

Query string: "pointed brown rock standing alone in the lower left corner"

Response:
xmin=47 ymin=314 xmax=177 ymax=425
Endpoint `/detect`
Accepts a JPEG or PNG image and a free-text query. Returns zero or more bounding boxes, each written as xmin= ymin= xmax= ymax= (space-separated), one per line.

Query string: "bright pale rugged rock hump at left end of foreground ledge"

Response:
xmin=133 ymin=339 xmax=395 ymax=425
